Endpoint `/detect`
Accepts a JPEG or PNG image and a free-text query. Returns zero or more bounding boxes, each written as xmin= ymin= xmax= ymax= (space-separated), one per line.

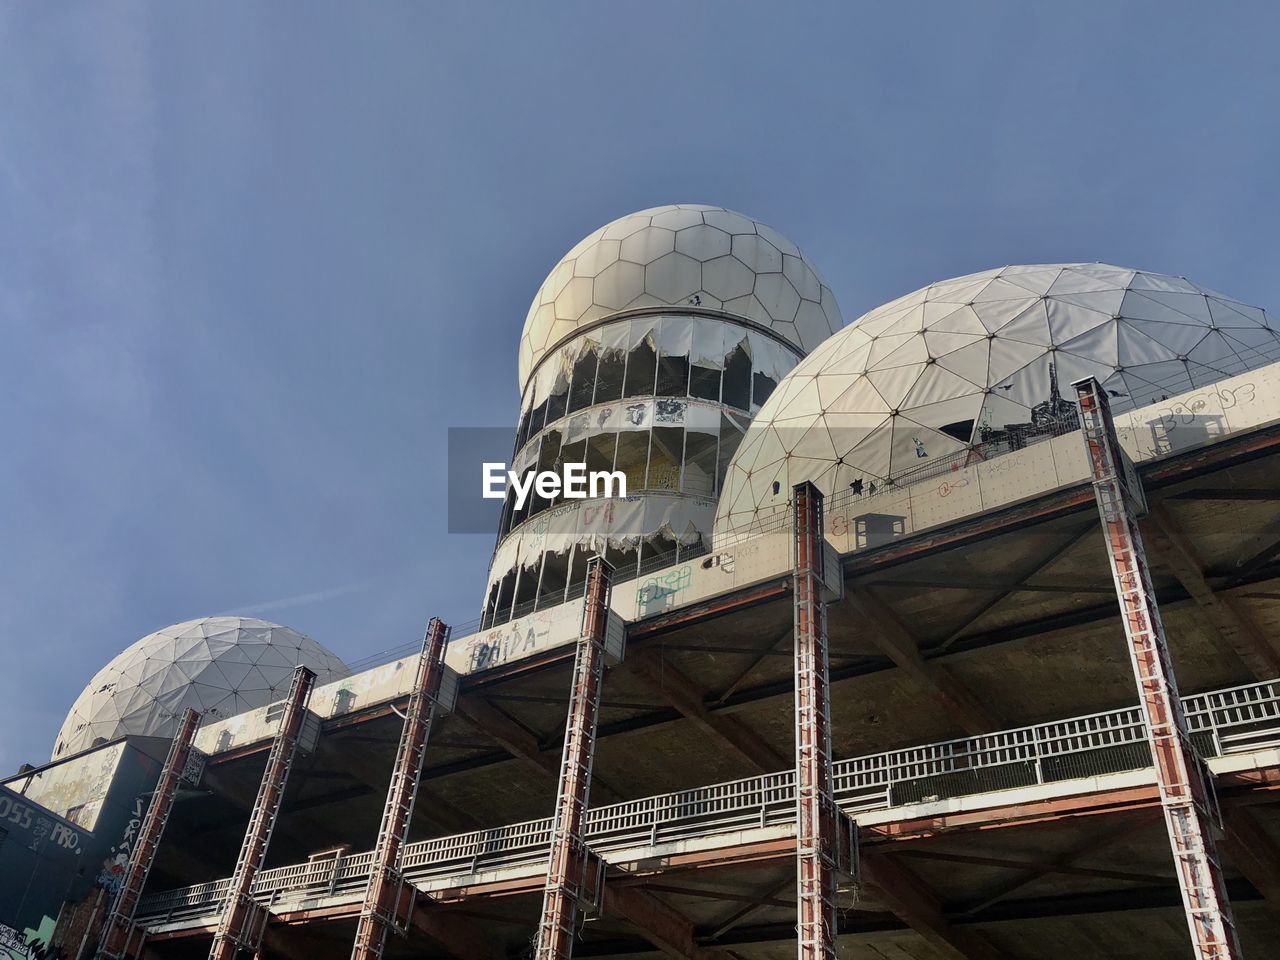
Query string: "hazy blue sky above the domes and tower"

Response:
xmin=0 ymin=0 xmax=1280 ymax=771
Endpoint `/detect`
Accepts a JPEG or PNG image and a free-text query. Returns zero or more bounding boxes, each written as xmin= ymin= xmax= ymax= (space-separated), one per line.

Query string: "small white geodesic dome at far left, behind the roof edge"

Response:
xmin=52 ymin=617 xmax=351 ymax=760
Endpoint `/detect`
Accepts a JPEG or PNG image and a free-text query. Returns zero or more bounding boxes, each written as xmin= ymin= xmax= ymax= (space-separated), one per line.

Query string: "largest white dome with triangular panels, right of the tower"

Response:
xmin=716 ymin=264 xmax=1280 ymax=538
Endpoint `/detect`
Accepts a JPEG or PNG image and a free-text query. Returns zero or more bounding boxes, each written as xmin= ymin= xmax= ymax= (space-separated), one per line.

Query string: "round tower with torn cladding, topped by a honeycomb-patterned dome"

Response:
xmin=483 ymin=204 xmax=842 ymax=626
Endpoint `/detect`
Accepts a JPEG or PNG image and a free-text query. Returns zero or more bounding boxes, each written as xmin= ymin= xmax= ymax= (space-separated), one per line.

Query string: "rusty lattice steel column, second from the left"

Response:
xmin=209 ymin=667 xmax=316 ymax=960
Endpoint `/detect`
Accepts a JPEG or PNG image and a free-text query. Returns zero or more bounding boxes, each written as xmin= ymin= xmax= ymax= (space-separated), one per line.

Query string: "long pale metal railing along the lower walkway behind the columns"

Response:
xmin=138 ymin=680 xmax=1280 ymax=924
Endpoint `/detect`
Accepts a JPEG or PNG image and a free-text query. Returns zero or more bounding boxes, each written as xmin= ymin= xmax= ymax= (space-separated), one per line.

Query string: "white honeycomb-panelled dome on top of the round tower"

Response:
xmin=520 ymin=204 xmax=842 ymax=390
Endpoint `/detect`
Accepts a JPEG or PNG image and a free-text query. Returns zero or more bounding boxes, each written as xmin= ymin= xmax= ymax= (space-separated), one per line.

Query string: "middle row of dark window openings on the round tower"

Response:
xmin=499 ymin=412 xmax=749 ymax=536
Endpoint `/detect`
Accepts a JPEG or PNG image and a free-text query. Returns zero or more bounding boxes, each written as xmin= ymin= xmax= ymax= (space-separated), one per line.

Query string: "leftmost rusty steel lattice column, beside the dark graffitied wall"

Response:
xmin=97 ymin=707 xmax=200 ymax=960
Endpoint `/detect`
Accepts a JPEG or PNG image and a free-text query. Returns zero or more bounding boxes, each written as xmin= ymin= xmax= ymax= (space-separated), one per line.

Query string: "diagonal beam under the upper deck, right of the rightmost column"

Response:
xmin=1144 ymin=504 xmax=1280 ymax=680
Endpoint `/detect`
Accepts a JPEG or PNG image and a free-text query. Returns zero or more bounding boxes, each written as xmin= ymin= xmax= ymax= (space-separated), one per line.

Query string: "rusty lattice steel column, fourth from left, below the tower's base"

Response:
xmin=534 ymin=557 xmax=611 ymax=960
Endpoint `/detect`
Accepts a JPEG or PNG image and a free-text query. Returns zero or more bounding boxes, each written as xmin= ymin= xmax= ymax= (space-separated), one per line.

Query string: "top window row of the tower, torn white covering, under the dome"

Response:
xmin=516 ymin=316 xmax=797 ymax=449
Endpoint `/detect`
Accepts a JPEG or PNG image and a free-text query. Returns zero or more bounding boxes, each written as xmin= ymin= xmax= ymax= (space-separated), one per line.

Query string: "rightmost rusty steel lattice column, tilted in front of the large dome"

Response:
xmin=1074 ymin=378 xmax=1243 ymax=960
